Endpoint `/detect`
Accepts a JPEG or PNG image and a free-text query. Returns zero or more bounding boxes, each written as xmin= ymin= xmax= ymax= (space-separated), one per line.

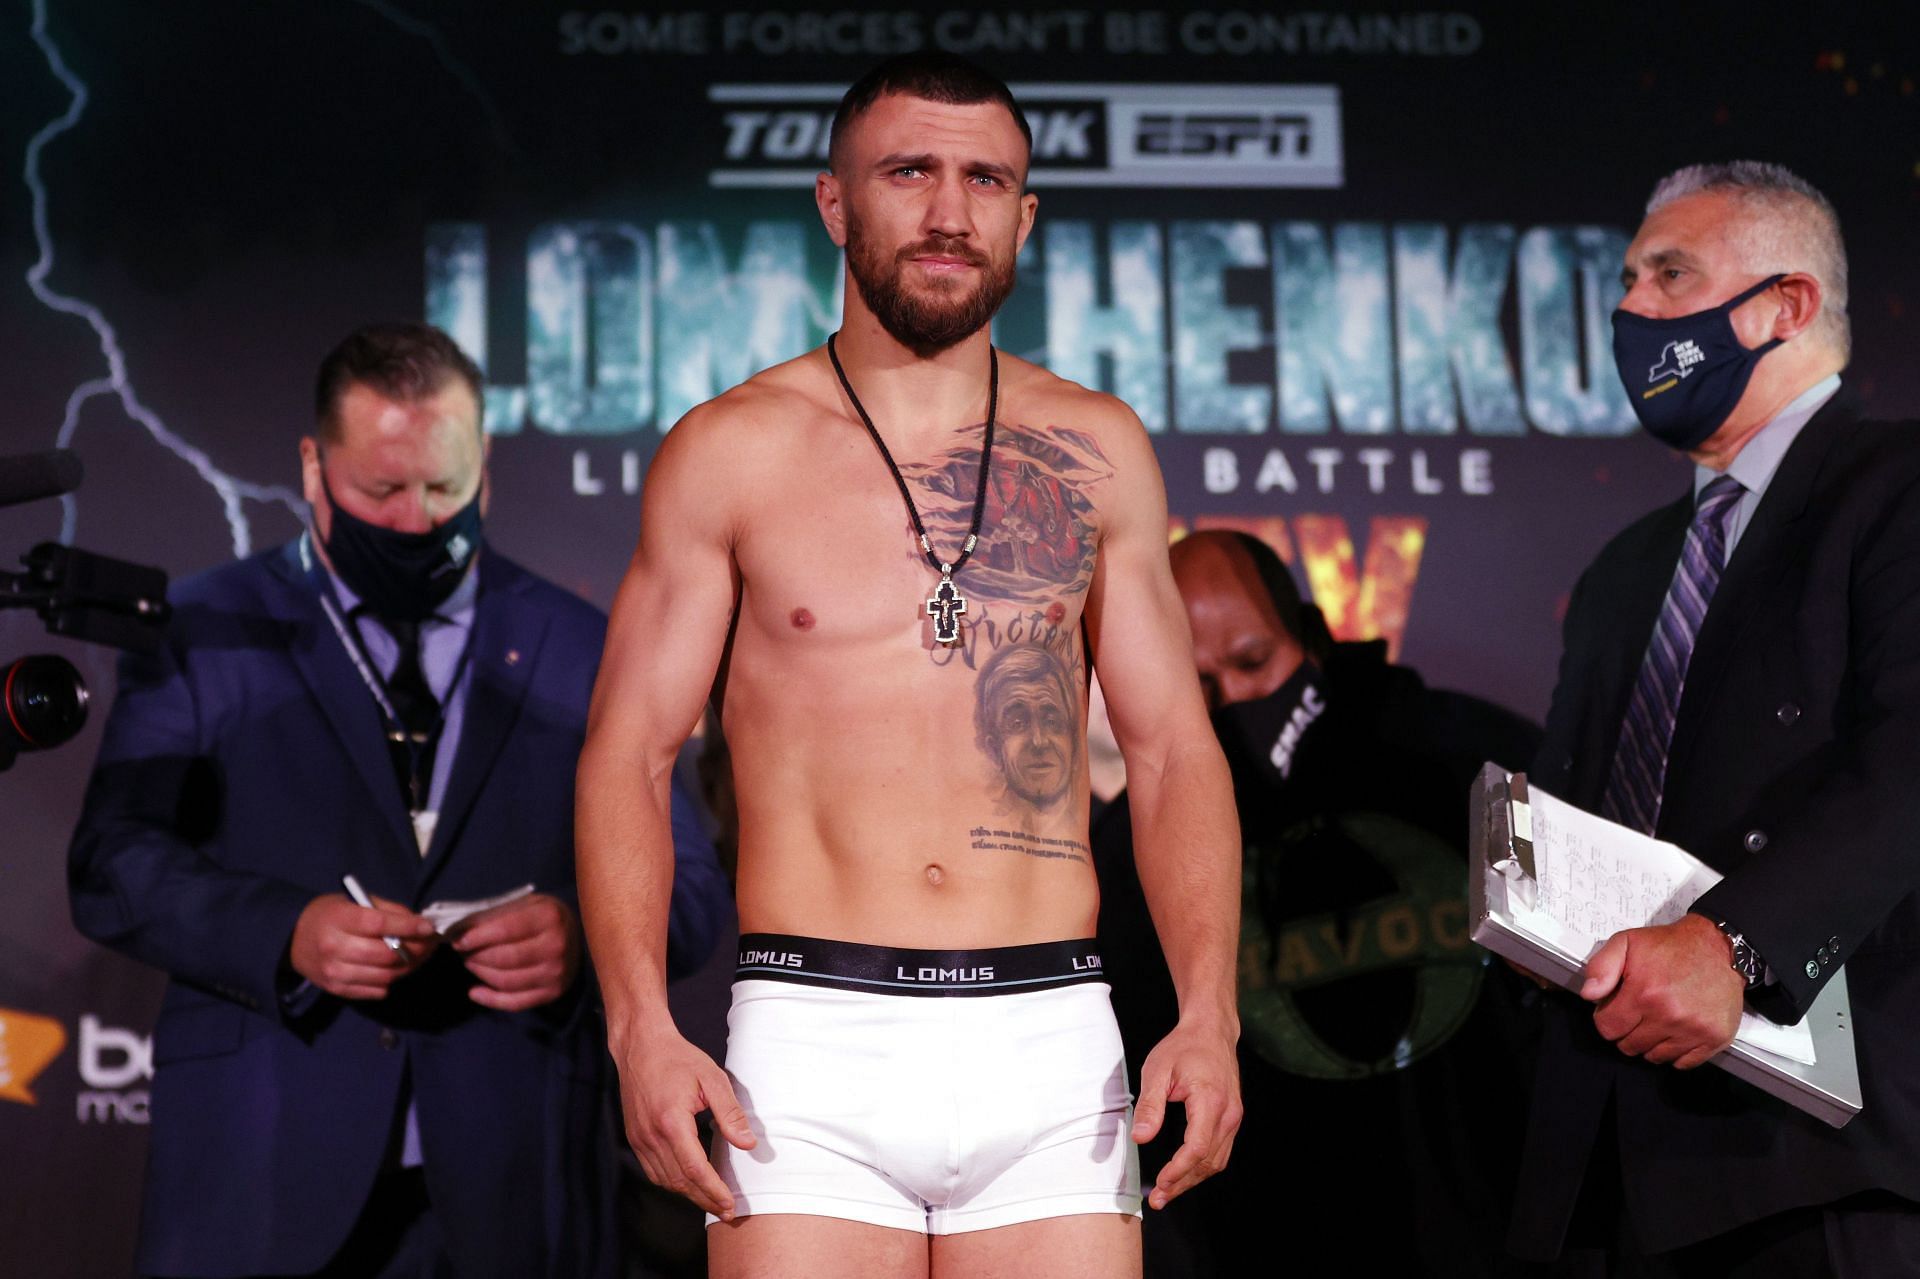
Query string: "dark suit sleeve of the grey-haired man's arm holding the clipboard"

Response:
xmin=1693 ymin=466 xmax=1920 ymax=1020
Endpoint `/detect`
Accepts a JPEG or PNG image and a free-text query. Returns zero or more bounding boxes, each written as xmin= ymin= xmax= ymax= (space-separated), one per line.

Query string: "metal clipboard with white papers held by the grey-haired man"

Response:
xmin=1469 ymin=764 xmax=1860 ymax=1127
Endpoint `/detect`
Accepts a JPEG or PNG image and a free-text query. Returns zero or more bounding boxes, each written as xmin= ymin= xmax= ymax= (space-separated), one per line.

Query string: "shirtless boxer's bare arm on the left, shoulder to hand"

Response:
xmin=576 ymin=401 xmax=753 ymax=1218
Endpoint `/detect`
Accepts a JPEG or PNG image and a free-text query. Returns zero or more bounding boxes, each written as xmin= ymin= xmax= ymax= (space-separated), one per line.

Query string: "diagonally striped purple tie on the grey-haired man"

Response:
xmin=1599 ymin=474 xmax=1747 ymax=835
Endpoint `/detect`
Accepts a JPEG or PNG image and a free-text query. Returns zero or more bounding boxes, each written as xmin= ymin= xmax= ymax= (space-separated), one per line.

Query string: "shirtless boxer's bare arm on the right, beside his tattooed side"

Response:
xmin=1087 ymin=401 xmax=1240 ymax=1208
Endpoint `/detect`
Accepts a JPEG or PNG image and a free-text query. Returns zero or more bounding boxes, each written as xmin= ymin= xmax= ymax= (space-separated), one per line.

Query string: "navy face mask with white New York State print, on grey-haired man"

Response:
xmin=1613 ymin=275 xmax=1788 ymax=453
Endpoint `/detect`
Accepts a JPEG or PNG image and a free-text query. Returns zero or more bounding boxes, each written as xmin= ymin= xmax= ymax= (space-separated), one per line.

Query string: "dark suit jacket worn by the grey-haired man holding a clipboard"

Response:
xmin=1513 ymin=392 xmax=1920 ymax=1256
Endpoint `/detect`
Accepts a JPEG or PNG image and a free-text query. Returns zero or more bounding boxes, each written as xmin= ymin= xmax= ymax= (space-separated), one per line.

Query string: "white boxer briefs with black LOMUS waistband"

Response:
xmin=707 ymin=933 xmax=1140 ymax=1235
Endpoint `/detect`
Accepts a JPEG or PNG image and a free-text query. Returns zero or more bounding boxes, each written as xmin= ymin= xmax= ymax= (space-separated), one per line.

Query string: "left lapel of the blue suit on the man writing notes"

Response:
xmin=269 ymin=542 xmax=417 ymax=860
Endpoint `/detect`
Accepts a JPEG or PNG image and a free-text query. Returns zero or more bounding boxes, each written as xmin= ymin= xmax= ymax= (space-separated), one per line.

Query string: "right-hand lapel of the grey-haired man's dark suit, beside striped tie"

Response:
xmin=1667 ymin=394 xmax=1857 ymax=780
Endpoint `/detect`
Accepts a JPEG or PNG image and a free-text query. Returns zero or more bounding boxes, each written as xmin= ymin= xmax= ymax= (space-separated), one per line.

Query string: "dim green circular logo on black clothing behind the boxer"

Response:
xmin=1240 ymin=812 xmax=1486 ymax=1079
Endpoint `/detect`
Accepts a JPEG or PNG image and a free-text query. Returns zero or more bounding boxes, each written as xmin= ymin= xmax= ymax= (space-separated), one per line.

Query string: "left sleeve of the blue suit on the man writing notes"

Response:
xmin=67 ymin=622 xmax=313 ymax=1012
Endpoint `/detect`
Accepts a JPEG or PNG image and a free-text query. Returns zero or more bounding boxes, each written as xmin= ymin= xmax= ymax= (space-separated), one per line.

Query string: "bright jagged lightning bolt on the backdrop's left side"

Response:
xmin=25 ymin=0 xmax=305 ymax=557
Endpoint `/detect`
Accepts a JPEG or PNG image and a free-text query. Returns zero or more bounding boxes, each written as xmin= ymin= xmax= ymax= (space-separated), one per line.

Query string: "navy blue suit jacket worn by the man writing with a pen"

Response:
xmin=69 ymin=543 xmax=726 ymax=1279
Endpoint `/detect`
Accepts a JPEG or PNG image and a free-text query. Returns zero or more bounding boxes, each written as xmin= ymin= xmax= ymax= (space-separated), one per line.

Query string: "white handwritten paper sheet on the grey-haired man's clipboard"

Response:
xmin=1517 ymin=787 xmax=1814 ymax=1066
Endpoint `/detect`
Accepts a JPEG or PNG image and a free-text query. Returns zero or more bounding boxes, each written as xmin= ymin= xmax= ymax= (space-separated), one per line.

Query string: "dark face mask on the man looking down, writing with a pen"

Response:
xmin=321 ymin=471 xmax=480 ymax=622
